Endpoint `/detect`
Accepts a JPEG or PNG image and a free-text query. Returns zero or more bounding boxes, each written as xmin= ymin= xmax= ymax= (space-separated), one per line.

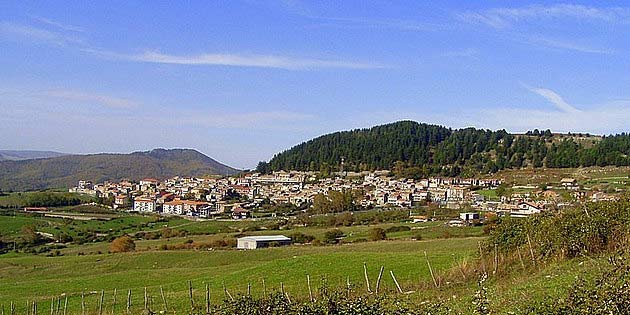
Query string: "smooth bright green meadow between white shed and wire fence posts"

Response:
xmin=0 ymin=238 xmax=481 ymax=311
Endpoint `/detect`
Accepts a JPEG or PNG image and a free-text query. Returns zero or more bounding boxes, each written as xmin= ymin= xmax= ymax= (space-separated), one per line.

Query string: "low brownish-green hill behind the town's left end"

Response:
xmin=0 ymin=149 xmax=237 ymax=191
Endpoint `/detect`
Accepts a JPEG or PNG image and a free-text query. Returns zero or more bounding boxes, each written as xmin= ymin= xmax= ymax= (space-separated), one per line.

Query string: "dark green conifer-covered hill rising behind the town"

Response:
xmin=258 ymin=121 xmax=630 ymax=176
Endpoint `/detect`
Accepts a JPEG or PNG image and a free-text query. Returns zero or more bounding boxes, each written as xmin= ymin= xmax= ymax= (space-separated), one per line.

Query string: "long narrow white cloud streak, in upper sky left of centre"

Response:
xmin=97 ymin=50 xmax=384 ymax=70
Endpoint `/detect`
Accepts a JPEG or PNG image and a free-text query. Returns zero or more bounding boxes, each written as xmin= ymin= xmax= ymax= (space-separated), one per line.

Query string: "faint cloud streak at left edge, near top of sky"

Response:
xmin=0 ymin=22 xmax=83 ymax=46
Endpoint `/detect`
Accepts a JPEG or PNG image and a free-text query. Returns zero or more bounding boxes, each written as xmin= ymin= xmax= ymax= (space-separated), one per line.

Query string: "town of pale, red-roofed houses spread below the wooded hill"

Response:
xmin=70 ymin=171 xmax=615 ymax=219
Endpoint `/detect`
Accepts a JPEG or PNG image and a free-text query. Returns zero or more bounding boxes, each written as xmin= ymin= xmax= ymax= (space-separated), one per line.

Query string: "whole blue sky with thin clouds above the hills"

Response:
xmin=0 ymin=1 xmax=630 ymax=168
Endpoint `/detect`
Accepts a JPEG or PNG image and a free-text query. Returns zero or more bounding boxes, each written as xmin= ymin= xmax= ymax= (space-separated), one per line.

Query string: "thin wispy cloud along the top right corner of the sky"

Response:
xmin=458 ymin=4 xmax=630 ymax=28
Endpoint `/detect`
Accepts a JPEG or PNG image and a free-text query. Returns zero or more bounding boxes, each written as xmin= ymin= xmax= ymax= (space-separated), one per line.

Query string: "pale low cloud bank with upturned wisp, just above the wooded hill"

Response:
xmin=350 ymin=88 xmax=630 ymax=135
